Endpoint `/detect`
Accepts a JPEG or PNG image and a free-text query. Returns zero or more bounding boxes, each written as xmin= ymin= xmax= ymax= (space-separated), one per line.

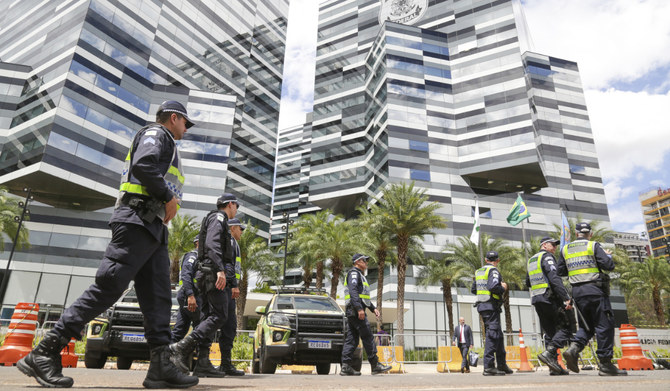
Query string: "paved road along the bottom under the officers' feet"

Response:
xmin=0 ymin=365 xmax=670 ymax=391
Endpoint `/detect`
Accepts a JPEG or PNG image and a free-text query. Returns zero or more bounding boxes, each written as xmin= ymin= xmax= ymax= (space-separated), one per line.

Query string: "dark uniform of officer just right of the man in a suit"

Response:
xmin=470 ymin=262 xmax=508 ymax=371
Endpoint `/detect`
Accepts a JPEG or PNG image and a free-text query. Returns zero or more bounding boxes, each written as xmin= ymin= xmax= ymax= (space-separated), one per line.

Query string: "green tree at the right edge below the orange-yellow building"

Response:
xmin=621 ymin=257 xmax=670 ymax=326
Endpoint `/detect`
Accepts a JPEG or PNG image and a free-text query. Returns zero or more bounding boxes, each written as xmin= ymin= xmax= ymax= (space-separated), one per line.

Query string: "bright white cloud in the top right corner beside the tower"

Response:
xmin=524 ymin=0 xmax=670 ymax=89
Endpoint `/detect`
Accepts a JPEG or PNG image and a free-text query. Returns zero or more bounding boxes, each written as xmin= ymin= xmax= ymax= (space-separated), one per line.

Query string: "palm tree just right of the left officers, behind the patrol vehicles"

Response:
xmin=235 ymin=224 xmax=276 ymax=329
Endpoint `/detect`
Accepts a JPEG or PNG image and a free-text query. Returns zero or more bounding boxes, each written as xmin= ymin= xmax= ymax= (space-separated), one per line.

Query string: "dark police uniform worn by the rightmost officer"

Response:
xmin=557 ymin=239 xmax=614 ymax=363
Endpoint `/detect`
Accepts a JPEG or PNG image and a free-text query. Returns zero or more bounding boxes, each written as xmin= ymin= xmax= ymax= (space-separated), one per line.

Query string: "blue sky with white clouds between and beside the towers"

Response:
xmin=279 ymin=0 xmax=670 ymax=236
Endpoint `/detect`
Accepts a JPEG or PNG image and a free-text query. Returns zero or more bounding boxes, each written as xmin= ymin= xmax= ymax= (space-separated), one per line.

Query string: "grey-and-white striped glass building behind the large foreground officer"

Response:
xmin=0 ymin=0 xmax=288 ymax=317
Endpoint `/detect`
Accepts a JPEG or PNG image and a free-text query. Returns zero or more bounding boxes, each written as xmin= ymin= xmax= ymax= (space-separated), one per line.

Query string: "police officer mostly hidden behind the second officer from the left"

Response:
xmin=219 ymin=219 xmax=245 ymax=376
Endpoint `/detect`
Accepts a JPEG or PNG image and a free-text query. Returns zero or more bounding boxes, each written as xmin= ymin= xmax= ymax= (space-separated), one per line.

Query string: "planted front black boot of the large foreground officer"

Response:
xmin=142 ymin=345 xmax=198 ymax=388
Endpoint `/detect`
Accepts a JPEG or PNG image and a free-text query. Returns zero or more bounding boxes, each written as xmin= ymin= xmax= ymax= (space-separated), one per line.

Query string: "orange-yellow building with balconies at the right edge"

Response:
xmin=640 ymin=187 xmax=670 ymax=260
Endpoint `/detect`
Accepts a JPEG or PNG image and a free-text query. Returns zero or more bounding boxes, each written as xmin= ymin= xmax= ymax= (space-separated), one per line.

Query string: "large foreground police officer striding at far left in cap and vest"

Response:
xmin=18 ymin=101 xmax=198 ymax=388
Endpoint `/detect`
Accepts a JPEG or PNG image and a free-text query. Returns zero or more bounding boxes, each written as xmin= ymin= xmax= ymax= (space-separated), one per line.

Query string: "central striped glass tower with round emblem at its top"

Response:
xmin=272 ymin=0 xmax=625 ymax=332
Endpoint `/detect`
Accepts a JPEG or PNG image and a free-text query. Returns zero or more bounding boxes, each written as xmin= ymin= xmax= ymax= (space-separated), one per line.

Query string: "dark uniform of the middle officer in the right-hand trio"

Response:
xmin=526 ymin=251 xmax=574 ymax=368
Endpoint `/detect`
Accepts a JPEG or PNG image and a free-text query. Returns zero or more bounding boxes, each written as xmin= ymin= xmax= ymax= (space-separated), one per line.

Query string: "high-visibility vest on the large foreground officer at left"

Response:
xmin=116 ymin=124 xmax=184 ymax=219
